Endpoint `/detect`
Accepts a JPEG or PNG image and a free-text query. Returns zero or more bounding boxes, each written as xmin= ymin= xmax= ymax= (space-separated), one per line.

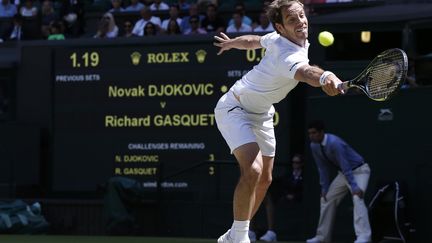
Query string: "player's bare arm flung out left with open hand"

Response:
xmin=213 ymin=32 xmax=262 ymax=55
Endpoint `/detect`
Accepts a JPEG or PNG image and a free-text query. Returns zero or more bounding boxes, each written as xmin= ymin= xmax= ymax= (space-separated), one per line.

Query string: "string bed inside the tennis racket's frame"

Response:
xmin=367 ymin=52 xmax=406 ymax=100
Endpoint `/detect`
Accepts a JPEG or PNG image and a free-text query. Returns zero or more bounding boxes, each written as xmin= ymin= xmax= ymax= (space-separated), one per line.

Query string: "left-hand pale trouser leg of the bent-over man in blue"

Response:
xmin=306 ymin=172 xmax=349 ymax=243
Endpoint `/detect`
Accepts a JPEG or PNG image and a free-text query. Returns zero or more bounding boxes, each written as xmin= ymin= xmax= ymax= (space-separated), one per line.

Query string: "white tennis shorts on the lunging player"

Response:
xmin=215 ymin=91 xmax=276 ymax=157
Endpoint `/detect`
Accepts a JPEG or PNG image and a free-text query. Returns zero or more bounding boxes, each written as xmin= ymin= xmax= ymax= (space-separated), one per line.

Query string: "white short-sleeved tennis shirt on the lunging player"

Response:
xmin=231 ymin=32 xmax=309 ymax=113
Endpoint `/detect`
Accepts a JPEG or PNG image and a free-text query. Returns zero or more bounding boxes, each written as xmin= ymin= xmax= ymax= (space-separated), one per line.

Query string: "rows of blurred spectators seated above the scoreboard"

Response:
xmin=0 ymin=0 xmax=362 ymax=41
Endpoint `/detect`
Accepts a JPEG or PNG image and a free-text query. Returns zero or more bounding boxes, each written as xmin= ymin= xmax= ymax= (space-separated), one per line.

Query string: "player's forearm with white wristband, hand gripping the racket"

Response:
xmin=294 ymin=65 xmax=342 ymax=96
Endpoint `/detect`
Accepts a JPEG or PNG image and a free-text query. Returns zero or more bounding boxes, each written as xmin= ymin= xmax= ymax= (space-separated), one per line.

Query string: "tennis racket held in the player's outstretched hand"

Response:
xmin=338 ymin=48 xmax=408 ymax=101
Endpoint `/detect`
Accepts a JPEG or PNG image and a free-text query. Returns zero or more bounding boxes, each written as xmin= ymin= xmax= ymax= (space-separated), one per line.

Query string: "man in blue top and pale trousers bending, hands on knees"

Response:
xmin=306 ymin=121 xmax=371 ymax=243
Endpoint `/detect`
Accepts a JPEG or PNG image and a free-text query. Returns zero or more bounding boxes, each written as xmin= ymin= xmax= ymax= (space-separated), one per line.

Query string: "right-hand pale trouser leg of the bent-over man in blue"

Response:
xmin=353 ymin=164 xmax=372 ymax=243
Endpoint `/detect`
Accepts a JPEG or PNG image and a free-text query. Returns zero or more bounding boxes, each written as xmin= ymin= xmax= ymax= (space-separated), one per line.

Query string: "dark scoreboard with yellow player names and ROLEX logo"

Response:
xmin=52 ymin=40 xmax=288 ymax=197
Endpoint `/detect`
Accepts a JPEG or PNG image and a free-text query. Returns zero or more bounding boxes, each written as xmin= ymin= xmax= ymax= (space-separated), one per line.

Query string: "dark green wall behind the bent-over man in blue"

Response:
xmin=305 ymin=87 xmax=432 ymax=242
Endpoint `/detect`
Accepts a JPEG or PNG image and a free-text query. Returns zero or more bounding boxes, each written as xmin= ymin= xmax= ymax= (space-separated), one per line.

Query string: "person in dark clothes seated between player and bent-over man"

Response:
xmin=249 ymin=154 xmax=304 ymax=242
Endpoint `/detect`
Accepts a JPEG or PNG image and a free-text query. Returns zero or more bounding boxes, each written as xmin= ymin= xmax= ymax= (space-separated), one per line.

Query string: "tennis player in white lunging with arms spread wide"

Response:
xmin=214 ymin=0 xmax=341 ymax=243
